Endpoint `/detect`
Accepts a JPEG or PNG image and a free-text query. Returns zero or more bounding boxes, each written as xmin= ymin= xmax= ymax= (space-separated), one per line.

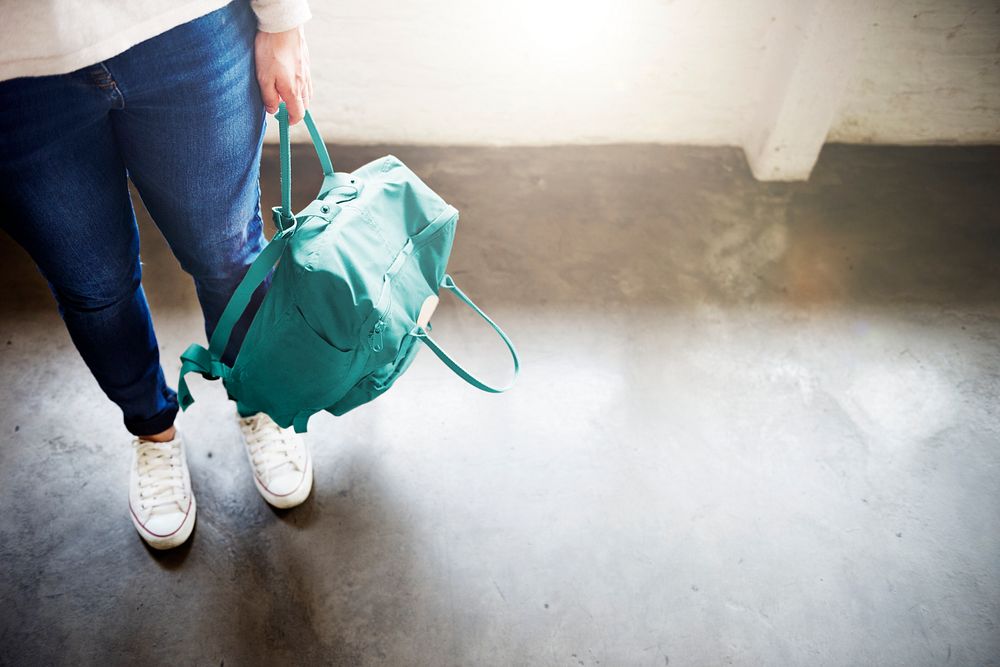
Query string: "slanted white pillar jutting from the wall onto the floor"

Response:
xmin=743 ymin=0 xmax=875 ymax=181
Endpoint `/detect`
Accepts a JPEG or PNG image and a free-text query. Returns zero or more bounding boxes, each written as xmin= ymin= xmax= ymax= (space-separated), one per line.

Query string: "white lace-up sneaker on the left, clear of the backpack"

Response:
xmin=128 ymin=433 xmax=195 ymax=549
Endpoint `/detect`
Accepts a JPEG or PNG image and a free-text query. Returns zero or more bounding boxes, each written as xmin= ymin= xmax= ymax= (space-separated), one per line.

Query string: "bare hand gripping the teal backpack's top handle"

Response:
xmin=254 ymin=26 xmax=312 ymax=125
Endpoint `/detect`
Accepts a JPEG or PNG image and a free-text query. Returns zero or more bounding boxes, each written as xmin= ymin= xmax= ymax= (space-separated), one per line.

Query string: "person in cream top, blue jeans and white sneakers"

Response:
xmin=0 ymin=0 xmax=312 ymax=549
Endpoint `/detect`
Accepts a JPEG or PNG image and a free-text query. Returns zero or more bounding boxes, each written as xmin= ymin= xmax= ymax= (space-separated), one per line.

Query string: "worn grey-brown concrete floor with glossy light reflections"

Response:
xmin=0 ymin=146 xmax=1000 ymax=667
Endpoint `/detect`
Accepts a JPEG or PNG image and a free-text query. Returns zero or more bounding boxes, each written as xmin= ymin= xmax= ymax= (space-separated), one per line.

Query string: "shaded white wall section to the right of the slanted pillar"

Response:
xmin=829 ymin=0 xmax=1000 ymax=144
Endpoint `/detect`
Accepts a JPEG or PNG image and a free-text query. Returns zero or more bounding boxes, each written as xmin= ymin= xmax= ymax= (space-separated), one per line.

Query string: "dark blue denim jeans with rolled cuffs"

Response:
xmin=0 ymin=0 xmax=266 ymax=435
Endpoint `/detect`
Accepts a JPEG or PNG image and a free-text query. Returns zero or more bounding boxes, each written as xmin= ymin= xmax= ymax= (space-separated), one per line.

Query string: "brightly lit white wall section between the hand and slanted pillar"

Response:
xmin=288 ymin=0 xmax=786 ymax=144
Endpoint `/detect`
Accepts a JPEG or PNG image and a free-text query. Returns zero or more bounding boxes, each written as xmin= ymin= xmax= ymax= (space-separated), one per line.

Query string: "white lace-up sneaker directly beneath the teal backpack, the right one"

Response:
xmin=239 ymin=412 xmax=313 ymax=509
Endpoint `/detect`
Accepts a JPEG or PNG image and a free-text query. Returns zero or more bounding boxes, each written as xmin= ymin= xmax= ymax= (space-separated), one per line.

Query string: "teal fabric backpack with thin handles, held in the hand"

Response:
xmin=178 ymin=104 xmax=519 ymax=432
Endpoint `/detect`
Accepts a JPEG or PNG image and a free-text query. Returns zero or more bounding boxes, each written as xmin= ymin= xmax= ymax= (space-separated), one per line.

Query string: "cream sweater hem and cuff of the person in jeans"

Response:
xmin=0 ymin=0 xmax=310 ymax=81
